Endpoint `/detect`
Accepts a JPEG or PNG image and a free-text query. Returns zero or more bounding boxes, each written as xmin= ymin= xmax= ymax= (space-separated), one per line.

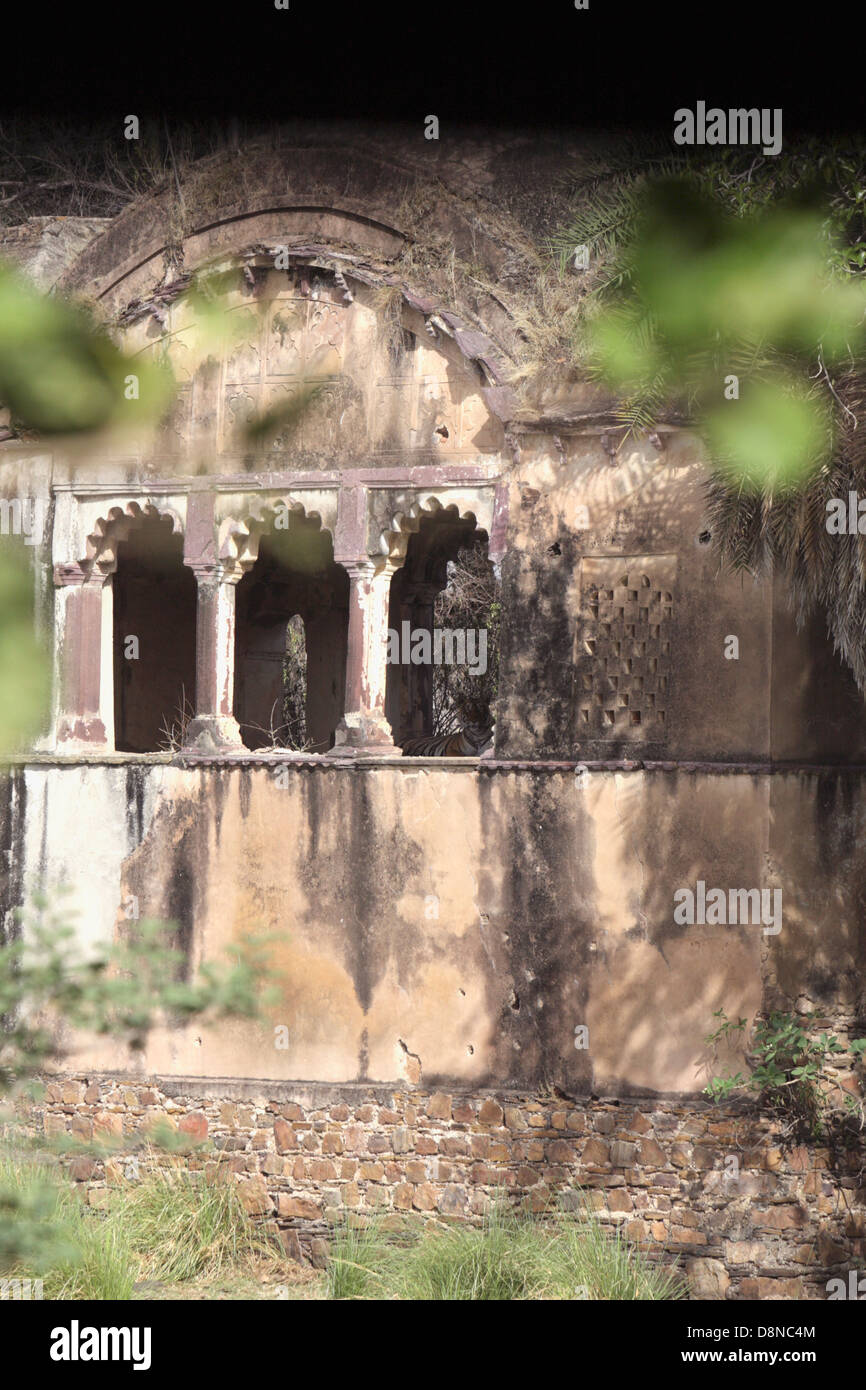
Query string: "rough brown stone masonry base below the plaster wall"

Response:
xmin=22 ymin=1074 xmax=866 ymax=1300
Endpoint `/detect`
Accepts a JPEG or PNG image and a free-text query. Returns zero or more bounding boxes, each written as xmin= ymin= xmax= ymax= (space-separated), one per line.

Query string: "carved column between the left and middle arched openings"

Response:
xmin=185 ymin=560 xmax=243 ymax=752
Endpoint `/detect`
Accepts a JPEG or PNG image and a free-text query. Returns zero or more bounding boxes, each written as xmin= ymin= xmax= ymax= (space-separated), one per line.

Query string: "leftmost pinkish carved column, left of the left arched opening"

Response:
xmin=54 ymin=563 xmax=114 ymax=749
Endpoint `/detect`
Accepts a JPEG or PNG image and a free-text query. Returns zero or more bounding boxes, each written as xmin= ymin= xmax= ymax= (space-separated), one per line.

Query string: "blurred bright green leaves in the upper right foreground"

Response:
xmin=589 ymin=177 xmax=866 ymax=488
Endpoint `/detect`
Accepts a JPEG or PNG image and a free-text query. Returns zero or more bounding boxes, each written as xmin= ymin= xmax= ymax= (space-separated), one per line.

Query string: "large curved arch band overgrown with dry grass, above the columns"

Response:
xmin=60 ymin=129 xmax=537 ymax=379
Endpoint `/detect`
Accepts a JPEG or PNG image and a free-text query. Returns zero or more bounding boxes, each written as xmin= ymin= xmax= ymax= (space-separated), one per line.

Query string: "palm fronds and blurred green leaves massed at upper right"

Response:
xmin=557 ymin=140 xmax=866 ymax=694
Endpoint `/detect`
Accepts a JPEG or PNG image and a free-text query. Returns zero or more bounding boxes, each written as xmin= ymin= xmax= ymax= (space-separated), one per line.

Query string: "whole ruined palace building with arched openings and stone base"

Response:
xmin=0 ymin=129 xmax=866 ymax=1297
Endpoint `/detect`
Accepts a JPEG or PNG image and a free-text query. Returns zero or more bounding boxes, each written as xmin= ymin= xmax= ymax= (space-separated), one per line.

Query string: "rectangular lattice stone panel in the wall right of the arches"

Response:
xmin=575 ymin=555 xmax=677 ymax=742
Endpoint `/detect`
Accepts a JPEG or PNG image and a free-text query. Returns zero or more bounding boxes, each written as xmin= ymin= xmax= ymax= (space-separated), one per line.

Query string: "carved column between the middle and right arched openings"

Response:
xmin=331 ymin=556 xmax=398 ymax=756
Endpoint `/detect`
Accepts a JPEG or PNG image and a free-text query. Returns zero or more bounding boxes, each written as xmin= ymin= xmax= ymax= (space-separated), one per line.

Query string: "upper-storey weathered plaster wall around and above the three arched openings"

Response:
xmin=0 ymin=190 xmax=866 ymax=762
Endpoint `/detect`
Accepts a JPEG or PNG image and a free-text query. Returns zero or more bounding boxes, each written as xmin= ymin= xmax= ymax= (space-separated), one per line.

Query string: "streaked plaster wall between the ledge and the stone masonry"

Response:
xmin=4 ymin=758 xmax=866 ymax=1095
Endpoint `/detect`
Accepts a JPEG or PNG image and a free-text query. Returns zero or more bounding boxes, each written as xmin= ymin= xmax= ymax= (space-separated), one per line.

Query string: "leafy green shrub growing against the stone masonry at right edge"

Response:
xmin=705 ymin=1009 xmax=866 ymax=1140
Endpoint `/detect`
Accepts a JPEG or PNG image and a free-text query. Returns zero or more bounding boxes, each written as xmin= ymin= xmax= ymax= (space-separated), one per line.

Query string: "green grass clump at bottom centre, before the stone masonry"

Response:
xmin=328 ymin=1201 xmax=684 ymax=1301
